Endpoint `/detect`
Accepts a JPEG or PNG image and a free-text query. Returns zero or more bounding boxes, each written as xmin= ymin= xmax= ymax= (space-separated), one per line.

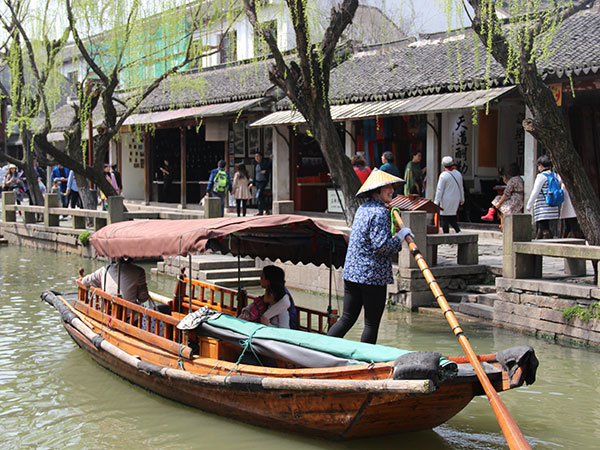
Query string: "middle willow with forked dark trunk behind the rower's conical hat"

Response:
xmin=244 ymin=0 xmax=360 ymax=222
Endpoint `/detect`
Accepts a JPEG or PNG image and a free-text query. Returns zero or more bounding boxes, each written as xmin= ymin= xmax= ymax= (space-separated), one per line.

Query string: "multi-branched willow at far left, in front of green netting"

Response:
xmin=5 ymin=0 xmax=239 ymax=207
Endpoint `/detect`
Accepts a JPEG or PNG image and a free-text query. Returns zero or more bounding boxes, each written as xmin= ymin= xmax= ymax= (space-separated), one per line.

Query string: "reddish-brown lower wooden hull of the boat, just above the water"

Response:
xmin=65 ymin=323 xmax=475 ymax=440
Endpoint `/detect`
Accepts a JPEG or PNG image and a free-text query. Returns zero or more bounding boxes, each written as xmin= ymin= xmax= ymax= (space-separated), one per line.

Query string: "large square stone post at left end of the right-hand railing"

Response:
xmin=502 ymin=214 xmax=542 ymax=278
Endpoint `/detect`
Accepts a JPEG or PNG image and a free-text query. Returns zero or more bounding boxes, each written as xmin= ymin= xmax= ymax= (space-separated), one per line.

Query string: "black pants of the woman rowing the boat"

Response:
xmin=327 ymin=280 xmax=387 ymax=344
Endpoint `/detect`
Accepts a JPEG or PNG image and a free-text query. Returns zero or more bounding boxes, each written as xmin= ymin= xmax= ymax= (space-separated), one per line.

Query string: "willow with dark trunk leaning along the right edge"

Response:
xmin=463 ymin=0 xmax=600 ymax=245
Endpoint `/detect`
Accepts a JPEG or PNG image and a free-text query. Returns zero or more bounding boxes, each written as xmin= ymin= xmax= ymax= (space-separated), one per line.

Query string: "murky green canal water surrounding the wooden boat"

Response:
xmin=0 ymin=246 xmax=600 ymax=450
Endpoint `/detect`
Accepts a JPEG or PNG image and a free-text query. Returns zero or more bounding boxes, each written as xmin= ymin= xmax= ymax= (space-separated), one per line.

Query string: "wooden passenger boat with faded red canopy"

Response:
xmin=42 ymin=216 xmax=537 ymax=440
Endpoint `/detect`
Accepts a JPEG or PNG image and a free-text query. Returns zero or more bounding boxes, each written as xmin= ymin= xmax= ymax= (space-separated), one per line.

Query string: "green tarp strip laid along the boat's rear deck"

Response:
xmin=208 ymin=314 xmax=411 ymax=363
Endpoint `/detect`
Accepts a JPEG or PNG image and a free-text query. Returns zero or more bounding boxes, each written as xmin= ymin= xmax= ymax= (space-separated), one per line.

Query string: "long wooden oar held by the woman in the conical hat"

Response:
xmin=393 ymin=209 xmax=531 ymax=449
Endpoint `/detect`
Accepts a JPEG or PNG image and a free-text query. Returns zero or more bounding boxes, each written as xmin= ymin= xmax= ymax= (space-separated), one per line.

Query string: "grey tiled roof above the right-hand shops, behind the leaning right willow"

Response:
xmin=330 ymin=8 xmax=600 ymax=104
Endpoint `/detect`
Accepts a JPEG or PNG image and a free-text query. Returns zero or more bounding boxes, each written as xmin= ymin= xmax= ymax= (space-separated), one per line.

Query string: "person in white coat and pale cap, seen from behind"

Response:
xmin=434 ymin=156 xmax=465 ymax=233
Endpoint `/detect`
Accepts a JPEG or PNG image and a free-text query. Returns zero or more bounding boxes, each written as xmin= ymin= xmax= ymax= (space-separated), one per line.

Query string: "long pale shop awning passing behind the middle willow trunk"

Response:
xmin=250 ymin=86 xmax=515 ymax=127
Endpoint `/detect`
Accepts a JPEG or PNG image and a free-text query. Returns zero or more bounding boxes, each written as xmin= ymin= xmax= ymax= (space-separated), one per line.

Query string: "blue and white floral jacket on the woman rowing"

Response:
xmin=342 ymin=199 xmax=402 ymax=286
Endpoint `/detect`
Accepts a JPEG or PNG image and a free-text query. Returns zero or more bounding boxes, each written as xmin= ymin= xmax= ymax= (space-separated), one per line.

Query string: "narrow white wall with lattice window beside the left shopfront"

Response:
xmin=121 ymin=133 xmax=149 ymax=200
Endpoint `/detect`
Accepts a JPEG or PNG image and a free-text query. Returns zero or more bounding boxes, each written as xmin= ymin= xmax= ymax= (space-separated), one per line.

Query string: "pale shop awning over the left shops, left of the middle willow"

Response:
xmin=124 ymin=97 xmax=267 ymax=125
